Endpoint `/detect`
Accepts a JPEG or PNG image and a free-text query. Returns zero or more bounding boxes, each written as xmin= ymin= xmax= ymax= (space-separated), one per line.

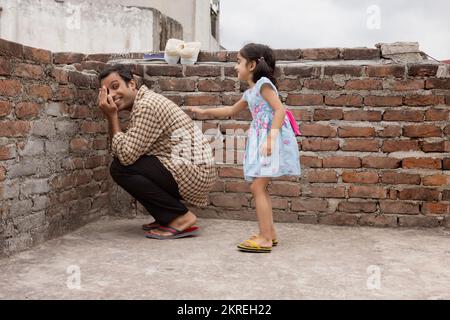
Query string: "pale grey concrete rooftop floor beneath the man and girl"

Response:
xmin=0 ymin=218 xmax=450 ymax=300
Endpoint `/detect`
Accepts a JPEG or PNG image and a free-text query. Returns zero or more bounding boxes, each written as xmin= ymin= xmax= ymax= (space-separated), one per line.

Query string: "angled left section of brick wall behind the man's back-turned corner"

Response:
xmin=0 ymin=39 xmax=110 ymax=256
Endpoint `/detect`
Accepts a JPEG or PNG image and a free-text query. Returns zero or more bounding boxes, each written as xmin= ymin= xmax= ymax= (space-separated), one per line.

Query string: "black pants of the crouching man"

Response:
xmin=110 ymin=155 xmax=189 ymax=225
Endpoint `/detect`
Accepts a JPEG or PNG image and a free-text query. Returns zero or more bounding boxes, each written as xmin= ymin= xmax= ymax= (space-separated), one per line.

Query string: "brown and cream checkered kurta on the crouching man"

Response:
xmin=112 ymin=85 xmax=217 ymax=206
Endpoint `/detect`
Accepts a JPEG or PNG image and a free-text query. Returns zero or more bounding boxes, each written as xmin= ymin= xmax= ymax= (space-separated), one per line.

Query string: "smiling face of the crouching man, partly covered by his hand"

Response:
xmin=101 ymin=72 xmax=137 ymax=111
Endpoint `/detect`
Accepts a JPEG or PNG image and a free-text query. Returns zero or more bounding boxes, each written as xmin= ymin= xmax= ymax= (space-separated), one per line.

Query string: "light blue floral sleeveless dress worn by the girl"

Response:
xmin=243 ymin=77 xmax=301 ymax=181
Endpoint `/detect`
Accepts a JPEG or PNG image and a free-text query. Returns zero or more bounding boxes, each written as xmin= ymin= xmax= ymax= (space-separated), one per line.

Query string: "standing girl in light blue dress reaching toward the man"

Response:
xmin=189 ymin=43 xmax=301 ymax=252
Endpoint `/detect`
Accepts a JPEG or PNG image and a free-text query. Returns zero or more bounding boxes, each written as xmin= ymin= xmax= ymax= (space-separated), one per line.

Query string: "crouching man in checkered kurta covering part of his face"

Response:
xmin=99 ymin=65 xmax=217 ymax=239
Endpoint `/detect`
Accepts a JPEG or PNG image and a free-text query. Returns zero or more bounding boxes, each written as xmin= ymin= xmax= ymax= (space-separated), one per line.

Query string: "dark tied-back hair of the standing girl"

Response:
xmin=239 ymin=43 xmax=277 ymax=86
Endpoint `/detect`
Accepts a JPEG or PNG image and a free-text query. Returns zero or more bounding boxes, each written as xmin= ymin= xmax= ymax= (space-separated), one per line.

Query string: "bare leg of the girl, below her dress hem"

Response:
xmin=251 ymin=178 xmax=274 ymax=247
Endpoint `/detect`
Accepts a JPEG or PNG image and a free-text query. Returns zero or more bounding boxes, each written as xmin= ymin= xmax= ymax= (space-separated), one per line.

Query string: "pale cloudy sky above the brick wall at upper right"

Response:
xmin=220 ymin=0 xmax=450 ymax=60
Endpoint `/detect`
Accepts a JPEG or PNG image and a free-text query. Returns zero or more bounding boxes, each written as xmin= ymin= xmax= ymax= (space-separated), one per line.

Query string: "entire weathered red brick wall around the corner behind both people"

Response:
xmin=0 ymin=37 xmax=450 ymax=252
